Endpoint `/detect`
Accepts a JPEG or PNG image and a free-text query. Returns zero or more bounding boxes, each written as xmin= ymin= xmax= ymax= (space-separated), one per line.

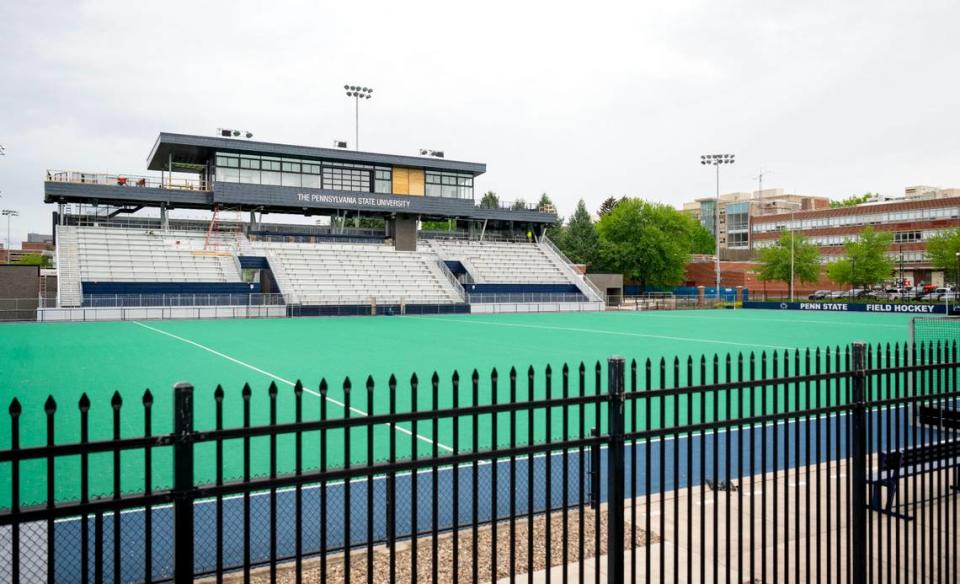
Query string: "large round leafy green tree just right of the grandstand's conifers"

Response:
xmin=597 ymin=198 xmax=692 ymax=287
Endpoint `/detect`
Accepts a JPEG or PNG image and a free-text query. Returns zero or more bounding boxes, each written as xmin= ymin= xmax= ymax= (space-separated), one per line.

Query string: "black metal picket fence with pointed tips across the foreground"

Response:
xmin=0 ymin=341 xmax=960 ymax=583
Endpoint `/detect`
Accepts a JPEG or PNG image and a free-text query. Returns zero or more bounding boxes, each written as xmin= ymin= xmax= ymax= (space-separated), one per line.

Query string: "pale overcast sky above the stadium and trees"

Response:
xmin=0 ymin=0 xmax=960 ymax=242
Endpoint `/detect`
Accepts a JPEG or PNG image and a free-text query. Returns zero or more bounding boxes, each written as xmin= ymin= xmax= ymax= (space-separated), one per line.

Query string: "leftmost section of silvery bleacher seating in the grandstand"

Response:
xmin=74 ymin=227 xmax=242 ymax=283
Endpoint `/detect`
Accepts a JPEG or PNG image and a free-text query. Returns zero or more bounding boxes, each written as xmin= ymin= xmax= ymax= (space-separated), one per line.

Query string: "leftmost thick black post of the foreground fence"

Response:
xmin=173 ymin=382 xmax=194 ymax=584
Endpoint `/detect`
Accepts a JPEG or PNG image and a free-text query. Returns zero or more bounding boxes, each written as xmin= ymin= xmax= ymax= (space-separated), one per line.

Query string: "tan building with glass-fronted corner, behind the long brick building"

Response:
xmin=683 ymin=188 xmax=830 ymax=253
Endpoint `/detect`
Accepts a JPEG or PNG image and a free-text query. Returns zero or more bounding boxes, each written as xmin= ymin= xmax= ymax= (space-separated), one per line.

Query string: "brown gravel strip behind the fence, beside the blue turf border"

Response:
xmin=208 ymin=509 xmax=660 ymax=584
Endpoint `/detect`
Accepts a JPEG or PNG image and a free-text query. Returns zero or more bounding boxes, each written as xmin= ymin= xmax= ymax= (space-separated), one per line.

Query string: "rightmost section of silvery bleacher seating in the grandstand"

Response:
xmin=422 ymin=240 xmax=570 ymax=284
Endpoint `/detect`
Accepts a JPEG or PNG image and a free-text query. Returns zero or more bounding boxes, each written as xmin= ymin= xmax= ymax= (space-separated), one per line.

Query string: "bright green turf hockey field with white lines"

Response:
xmin=0 ymin=310 xmax=910 ymax=506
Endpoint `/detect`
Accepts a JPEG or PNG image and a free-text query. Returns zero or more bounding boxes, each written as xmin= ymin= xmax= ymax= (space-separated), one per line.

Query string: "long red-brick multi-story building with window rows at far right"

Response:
xmin=751 ymin=186 xmax=960 ymax=285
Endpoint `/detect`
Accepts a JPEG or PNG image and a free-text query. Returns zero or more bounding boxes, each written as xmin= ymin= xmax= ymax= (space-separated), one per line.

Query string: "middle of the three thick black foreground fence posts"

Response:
xmin=607 ymin=355 xmax=625 ymax=584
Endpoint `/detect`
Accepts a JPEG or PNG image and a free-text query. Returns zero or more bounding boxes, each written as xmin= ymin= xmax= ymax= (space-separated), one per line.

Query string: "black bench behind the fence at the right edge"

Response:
xmin=867 ymin=416 xmax=960 ymax=521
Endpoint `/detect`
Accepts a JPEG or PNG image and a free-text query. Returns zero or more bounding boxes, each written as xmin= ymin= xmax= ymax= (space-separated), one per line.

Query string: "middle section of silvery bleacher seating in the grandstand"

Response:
xmin=252 ymin=241 xmax=463 ymax=304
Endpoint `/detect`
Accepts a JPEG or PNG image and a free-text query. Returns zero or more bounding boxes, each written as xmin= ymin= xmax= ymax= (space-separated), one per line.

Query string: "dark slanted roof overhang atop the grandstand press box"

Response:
xmin=147 ymin=132 xmax=487 ymax=176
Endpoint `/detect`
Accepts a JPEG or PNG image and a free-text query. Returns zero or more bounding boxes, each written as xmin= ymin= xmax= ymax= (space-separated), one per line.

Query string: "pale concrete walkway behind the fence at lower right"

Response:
xmin=499 ymin=461 xmax=960 ymax=583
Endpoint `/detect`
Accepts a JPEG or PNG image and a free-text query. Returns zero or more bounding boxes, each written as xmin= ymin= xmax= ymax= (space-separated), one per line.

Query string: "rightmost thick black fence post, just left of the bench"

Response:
xmin=850 ymin=341 xmax=869 ymax=584
